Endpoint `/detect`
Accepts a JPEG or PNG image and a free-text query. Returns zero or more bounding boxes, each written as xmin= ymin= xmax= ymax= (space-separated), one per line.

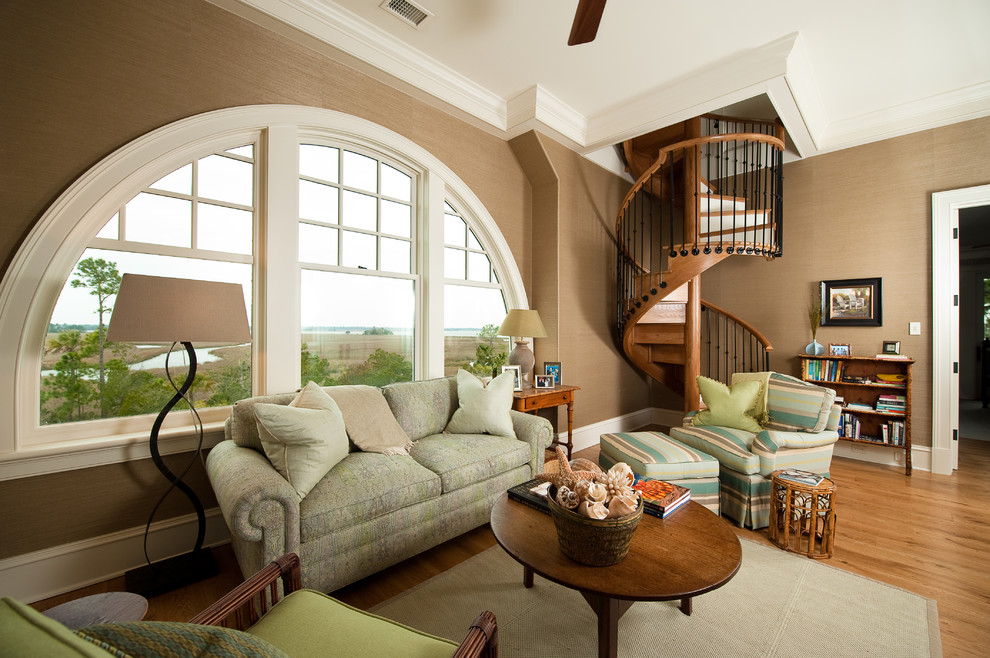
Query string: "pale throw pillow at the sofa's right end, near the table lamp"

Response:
xmin=445 ymin=370 xmax=516 ymax=438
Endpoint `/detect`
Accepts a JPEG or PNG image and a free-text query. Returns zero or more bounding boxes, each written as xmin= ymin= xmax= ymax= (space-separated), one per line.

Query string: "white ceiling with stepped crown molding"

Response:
xmin=210 ymin=0 xmax=990 ymax=163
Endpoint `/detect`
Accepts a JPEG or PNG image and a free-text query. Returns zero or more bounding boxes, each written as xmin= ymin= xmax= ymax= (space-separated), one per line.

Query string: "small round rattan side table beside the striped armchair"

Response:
xmin=768 ymin=471 xmax=835 ymax=559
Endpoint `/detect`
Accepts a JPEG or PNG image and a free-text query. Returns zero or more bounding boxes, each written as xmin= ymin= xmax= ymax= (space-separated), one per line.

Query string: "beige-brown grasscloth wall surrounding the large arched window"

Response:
xmin=0 ymin=0 xmax=628 ymax=558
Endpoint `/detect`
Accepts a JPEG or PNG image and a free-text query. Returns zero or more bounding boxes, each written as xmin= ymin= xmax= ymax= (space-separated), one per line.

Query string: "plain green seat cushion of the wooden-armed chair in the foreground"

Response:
xmin=248 ymin=589 xmax=467 ymax=658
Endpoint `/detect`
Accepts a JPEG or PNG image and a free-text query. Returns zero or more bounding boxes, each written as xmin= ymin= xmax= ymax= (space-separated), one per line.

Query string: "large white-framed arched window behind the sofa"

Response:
xmin=0 ymin=106 xmax=526 ymax=474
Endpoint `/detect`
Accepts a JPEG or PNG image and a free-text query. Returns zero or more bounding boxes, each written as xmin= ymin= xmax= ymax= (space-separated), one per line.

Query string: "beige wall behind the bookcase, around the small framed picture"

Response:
xmin=702 ymin=119 xmax=990 ymax=446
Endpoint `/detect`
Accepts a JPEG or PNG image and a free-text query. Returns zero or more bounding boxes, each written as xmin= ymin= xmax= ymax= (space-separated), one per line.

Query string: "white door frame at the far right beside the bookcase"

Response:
xmin=932 ymin=185 xmax=990 ymax=475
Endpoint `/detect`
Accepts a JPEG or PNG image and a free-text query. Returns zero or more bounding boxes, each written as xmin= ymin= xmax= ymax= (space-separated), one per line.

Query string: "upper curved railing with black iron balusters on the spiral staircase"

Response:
xmin=616 ymin=116 xmax=784 ymax=335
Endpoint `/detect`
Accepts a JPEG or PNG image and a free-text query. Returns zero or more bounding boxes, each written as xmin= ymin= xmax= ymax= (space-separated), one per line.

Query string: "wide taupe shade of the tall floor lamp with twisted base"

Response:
xmin=107 ymin=274 xmax=251 ymax=343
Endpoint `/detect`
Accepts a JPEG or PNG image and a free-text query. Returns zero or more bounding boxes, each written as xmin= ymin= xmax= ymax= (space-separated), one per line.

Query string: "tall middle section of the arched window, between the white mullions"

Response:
xmin=299 ymin=144 xmax=417 ymax=386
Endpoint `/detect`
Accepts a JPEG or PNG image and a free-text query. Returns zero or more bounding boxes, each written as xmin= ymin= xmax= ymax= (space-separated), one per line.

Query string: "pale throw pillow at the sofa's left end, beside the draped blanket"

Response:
xmin=254 ymin=382 xmax=349 ymax=498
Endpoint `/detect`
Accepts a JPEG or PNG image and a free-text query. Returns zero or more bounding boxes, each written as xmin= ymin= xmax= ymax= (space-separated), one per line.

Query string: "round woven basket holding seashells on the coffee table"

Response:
xmin=547 ymin=487 xmax=643 ymax=567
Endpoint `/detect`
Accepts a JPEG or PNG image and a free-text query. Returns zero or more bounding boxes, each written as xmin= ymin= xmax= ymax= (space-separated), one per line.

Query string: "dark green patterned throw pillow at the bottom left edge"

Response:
xmin=76 ymin=621 xmax=286 ymax=658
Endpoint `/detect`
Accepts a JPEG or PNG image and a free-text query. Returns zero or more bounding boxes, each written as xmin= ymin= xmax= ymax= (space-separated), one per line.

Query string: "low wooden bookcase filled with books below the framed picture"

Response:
xmin=798 ymin=354 xmax=914 ymax=475
